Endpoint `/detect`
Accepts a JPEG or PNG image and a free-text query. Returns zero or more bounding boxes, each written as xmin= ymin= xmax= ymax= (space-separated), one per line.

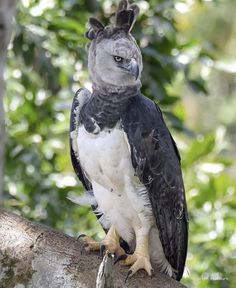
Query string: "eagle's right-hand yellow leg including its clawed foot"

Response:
xmin=120 ymin=231 xmax=153 ymax=278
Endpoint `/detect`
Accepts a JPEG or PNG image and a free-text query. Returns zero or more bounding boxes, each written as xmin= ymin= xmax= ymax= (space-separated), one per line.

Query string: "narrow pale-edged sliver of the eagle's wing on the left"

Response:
xmin=70 ymin=88 xmax=92 ymax=191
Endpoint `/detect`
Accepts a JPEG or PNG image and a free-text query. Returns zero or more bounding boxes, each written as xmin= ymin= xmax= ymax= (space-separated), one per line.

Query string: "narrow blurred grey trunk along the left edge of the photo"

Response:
xmin=0 ymin=0 xmax=17 ymax=205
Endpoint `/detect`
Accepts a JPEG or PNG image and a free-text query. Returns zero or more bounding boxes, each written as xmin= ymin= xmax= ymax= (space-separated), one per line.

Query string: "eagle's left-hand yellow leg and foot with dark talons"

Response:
xmin=79 ymin=226 xmax=125 ymax=256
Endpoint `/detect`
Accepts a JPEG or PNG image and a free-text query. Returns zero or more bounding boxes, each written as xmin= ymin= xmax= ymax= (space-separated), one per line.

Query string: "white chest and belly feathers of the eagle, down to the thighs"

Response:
xmin=77 ymin=125 xmax=153 ymax=243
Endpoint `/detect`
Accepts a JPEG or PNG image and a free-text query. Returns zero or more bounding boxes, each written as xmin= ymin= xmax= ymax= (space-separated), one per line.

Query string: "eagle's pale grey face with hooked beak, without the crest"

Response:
xmin=89 ymin=36 xmax=142 ymax=87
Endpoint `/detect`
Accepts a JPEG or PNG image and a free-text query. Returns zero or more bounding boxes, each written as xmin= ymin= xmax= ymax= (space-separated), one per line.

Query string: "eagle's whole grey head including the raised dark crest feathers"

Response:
xmin=86 ymin=0 xmax=143 ymax=87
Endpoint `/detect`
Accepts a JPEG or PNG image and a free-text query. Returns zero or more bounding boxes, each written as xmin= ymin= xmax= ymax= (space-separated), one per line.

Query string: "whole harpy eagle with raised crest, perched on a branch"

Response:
xmin=70 ymin=1 xmax=188 ymax=280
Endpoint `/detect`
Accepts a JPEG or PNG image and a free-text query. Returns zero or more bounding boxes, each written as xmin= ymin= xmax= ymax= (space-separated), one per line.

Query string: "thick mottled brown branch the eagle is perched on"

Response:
xmin=0 ymin=209 xmax=188 ymax=288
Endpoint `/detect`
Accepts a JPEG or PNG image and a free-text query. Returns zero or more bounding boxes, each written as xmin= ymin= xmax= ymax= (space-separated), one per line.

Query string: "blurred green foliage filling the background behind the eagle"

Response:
xmin=4 ymin=0 xmax=236 ymax=287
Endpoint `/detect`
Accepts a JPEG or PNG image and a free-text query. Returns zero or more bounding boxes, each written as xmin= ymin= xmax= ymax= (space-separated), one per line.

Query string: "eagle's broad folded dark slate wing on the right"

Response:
xmin=121 ymin=95 xmax=188 ymax=280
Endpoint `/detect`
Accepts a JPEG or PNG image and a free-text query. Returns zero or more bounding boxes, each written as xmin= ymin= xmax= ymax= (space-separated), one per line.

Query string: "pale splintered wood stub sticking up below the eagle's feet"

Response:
xmin=96 ymin=252 xmax=114 ymax=288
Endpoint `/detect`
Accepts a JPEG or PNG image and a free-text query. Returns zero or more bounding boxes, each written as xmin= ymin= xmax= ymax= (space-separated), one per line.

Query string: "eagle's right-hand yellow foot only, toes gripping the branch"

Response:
xmin=116 ymin=252 xmax=153 ymax=280
